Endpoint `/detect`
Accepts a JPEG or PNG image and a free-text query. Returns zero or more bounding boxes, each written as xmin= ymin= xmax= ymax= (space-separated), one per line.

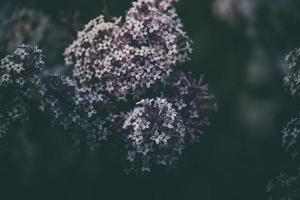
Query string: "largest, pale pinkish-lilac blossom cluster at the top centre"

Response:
xmin=65 ymin=0 xmax=191 ymax=99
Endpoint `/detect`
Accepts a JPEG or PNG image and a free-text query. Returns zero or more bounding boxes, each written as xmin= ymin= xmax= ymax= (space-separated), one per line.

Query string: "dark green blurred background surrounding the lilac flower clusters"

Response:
xmin=0 ymin=0 xmax=300 ymax=200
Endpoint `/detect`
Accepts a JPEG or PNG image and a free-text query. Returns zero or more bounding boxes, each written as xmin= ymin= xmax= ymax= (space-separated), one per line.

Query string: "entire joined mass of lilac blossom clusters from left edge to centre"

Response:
xmin=0 ymin=0 xmax=216 ymax=174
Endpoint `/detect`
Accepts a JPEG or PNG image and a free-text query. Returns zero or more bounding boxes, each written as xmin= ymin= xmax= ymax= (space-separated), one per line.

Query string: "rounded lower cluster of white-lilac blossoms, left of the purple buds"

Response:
xmin=123 ymin=98 xmax=185 ymax=173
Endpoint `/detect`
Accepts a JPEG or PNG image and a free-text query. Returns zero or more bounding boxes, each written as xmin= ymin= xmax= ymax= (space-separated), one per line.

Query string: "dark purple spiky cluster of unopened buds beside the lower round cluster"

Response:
xmin=167 ymin=72 xmax=217 ymax=142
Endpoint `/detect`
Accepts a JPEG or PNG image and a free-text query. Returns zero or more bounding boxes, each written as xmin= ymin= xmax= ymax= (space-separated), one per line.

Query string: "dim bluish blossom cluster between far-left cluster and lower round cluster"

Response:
xmin=39 ymin=75 xmax=118 ymax=150
